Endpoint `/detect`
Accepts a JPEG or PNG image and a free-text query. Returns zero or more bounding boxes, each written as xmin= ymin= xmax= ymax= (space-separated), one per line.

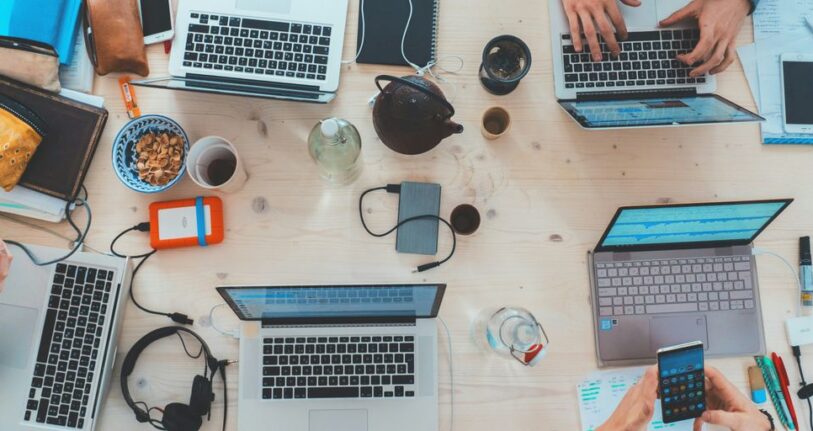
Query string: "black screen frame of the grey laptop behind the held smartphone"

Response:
xmin=595 ymin=199 xmax=793 ymax=252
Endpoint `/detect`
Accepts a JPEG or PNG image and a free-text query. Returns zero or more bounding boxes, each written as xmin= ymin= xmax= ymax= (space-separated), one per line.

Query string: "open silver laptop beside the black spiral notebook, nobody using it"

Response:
xmin=133 ymin=0 xmax=348 ymax=103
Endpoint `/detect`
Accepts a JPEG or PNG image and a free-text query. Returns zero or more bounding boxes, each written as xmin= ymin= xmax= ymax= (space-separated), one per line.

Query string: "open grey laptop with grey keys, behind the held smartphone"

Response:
xmin=588 ymin=199 xmax=792 ymax=366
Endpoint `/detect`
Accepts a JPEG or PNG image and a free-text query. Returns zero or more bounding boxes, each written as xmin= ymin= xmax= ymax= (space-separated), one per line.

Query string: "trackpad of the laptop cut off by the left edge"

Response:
xmin=0 ymin=304 xmax=37 ymax=369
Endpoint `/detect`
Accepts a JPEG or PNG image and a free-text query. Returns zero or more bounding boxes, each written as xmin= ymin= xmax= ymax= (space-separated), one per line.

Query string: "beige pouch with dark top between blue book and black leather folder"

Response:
xmin=0 ymin=36 xmax=62 ymax=93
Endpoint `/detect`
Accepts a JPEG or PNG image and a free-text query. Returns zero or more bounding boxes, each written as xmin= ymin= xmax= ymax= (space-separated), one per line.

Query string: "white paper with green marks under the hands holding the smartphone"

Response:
xmin=577 ymin=367 xmax=694 ymax=431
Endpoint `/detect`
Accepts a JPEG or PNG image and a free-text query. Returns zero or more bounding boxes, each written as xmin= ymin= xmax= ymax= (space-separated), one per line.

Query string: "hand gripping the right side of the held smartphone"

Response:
xmin=694 ymin=367 xmax=771 ymax=431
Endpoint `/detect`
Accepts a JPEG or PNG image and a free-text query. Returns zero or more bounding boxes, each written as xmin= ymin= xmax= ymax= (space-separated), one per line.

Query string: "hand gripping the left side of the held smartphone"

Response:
xmin=596 ymin=367 xmax=658 ymax=431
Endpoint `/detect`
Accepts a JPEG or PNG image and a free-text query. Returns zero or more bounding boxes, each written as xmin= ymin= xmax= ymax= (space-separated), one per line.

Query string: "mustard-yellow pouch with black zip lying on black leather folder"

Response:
xmin=0 ymin=95 xmax=45 ymax=192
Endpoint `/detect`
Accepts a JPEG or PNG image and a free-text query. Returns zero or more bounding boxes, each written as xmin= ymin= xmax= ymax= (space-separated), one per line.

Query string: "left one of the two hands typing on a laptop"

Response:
xmin=562 ymin=0 xmax=640 ymax=61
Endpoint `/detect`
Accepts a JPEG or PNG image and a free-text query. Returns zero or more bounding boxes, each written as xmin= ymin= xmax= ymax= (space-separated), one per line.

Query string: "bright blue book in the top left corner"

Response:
xmin=0 ymin=0 xmax=82 ymax=64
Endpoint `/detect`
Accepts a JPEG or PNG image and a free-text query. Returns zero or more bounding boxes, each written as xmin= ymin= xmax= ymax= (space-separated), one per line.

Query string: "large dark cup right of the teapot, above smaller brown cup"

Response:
xmin=480 ymin=35 xmax=531 ymax=96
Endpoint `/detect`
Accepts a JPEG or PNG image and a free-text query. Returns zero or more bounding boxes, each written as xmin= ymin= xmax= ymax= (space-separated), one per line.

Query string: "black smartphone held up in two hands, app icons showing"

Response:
xmin=658 ymin=341 xmax=706 ymax=424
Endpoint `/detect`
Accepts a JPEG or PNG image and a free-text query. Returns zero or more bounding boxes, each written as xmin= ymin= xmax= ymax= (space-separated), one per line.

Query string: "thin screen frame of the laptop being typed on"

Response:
xmin=559 ymin=92 xmax=765 ymax=130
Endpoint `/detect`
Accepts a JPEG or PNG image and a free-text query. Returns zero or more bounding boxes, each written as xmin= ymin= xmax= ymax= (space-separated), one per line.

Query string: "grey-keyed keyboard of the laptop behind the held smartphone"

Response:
xmin=596 ymin=256 xmax=756 ymax=317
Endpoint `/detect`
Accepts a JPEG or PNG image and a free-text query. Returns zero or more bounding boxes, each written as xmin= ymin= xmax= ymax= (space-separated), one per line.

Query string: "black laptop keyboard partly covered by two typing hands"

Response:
xmin=562 ymin=29 xmax=707 ymax=89
